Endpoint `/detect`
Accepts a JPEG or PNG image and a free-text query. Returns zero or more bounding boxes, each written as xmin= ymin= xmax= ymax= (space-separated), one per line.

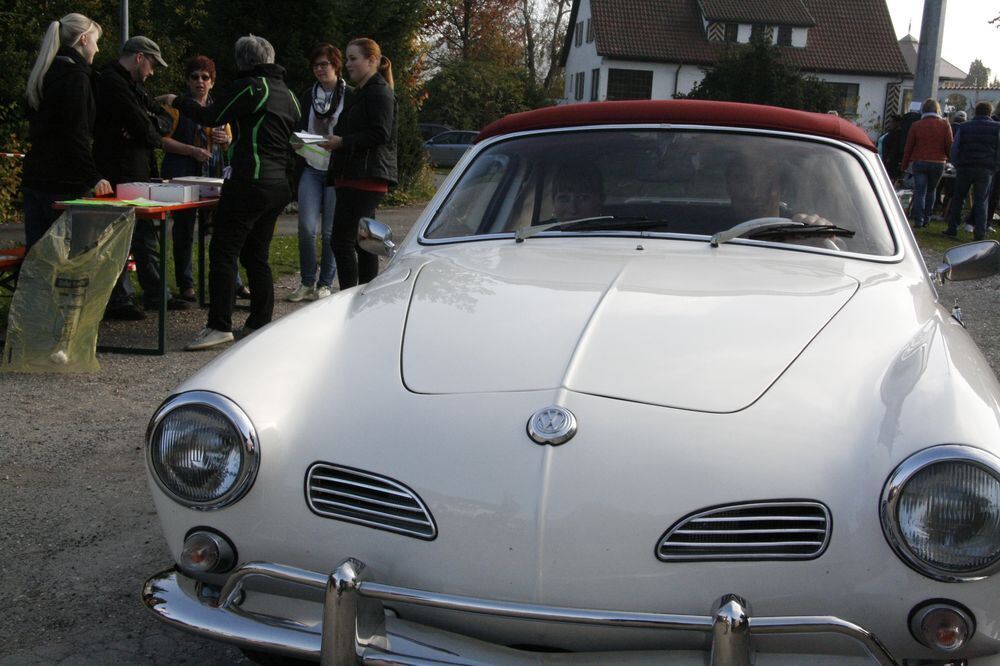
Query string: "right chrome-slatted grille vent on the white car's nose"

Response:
xmin=656 ymin=500 xmax=831 ymax=562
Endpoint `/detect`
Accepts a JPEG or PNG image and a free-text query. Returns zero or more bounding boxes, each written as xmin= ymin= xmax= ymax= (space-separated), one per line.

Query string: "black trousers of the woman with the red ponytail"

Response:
xmin=332 ymin=187 xmax=385 ymax=291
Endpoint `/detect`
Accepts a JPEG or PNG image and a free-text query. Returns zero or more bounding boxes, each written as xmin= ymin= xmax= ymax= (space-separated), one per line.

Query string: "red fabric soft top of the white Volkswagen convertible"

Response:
xmin=476 ymin=99 xmax=875 ymax=151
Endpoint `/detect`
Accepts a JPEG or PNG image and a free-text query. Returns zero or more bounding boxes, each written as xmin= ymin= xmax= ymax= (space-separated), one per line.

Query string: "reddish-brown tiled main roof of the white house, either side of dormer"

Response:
xmin=563 ymin=0 xmax=909 ymax=76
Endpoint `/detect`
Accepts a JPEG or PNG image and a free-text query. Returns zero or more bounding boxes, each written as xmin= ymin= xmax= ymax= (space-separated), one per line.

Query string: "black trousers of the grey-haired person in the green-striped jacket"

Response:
xmin=208 ymin=180 xmax=292 ymax=331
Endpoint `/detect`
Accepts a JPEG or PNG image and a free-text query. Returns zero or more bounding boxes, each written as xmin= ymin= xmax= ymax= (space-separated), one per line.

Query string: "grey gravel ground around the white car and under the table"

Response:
xmin=0 ymin=237 xmax=1000 ymax=666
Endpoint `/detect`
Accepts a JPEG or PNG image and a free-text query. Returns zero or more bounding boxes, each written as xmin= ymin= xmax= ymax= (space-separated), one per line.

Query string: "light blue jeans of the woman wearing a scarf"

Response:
xmin=299 ymin=164 xmax=337 ymax=287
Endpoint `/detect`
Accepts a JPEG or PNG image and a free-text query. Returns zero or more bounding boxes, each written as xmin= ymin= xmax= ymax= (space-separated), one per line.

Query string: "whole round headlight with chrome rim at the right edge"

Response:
xmin=881 ymin=444 xmax=1000 ymax=582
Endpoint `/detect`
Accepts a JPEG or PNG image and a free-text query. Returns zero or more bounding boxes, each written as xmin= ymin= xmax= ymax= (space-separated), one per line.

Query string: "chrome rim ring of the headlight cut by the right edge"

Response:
xmin=879 ymin=444 xmax=1000 ymax=583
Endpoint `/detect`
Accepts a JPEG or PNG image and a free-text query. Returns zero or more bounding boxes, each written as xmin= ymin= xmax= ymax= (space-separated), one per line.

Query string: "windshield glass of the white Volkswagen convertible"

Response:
xmin=423 ymin=129 xmax=894 ymax=255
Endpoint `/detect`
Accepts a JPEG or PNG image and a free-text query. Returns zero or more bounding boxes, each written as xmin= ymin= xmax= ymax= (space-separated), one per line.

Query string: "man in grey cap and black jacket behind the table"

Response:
xmin=94 ymin=36 xmax=186 ymax=319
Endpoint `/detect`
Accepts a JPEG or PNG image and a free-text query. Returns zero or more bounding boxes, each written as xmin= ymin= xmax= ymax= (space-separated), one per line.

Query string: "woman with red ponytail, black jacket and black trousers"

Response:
xmin=324 ymin=37 xmax=397 ymax=290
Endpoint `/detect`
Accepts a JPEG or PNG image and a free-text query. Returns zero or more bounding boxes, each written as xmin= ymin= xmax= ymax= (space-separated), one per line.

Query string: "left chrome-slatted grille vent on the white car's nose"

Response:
xmin=306 ymin=463 xmax=437 ymax=540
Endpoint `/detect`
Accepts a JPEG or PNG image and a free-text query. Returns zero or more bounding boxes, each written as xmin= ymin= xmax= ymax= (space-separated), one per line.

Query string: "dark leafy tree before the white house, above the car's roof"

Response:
xmin=679 ymin=32 xmax=836 ymax=112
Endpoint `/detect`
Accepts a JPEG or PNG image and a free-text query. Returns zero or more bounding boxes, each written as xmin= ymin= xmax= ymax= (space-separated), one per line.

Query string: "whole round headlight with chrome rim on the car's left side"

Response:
xmin=146 ymin=391 xmax=259 ymax=509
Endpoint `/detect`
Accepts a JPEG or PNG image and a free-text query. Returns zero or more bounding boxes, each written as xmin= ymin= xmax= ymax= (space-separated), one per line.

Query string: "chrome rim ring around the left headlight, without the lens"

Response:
xmin=146 ymin=391 xmax=260 ymax=511
